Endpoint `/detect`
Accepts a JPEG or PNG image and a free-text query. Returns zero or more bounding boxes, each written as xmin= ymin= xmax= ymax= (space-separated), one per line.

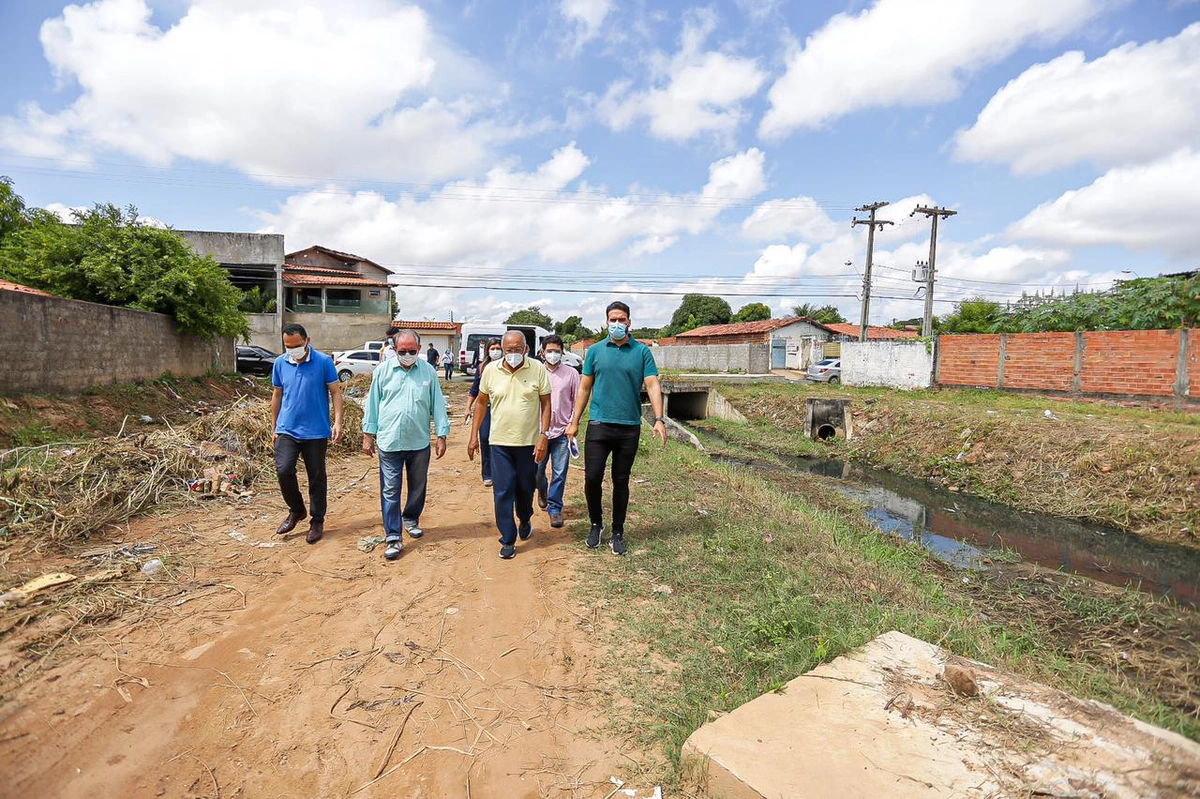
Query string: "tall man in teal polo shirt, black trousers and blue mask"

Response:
xmin=564 ymin=302 xmax=667 ymax=555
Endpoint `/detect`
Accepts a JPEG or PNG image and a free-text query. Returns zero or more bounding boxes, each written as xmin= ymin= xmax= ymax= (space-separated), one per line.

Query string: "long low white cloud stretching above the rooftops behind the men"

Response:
xmin=255 ymin=144 xmax=766 ymax=272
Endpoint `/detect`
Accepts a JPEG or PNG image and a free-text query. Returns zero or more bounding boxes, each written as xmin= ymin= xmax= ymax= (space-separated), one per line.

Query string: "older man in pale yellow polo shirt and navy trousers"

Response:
xmin=467 ymin=330 xmax=551 ymax=560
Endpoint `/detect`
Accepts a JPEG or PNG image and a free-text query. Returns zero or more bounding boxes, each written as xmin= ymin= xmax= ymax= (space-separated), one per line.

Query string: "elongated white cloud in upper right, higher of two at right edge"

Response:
xmin=954 ymin=23 xmax=1200 ymax=174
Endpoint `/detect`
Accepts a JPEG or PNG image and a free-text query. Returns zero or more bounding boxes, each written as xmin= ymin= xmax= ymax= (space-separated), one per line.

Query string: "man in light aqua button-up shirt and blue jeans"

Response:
xmin=362 ymin=330 xmax=450 ymax=560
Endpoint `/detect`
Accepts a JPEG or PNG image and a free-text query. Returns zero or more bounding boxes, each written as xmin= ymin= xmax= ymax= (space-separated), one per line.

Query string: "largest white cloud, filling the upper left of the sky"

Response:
xmin=0 ymin=0 xmax=520 ymax=182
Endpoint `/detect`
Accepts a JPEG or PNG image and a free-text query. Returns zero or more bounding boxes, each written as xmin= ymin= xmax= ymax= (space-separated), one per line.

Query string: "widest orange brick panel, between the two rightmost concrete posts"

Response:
xmin=1079 ymin=330 xmax=1180 ymax=396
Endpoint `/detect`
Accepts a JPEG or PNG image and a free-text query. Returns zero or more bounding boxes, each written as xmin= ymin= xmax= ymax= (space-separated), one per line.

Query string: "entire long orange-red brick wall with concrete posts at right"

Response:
xmin=931 ymin=330 xmax=1200 ymax=401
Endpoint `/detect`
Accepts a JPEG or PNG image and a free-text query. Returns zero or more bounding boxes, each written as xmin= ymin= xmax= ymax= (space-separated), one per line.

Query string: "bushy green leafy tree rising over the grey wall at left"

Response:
xmin=0 ymin=205 xmax=250 ymax=340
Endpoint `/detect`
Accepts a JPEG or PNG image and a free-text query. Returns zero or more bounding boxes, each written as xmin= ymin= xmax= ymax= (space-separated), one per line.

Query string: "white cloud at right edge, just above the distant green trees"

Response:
xmin=1009 ymin=148 xmax=1200 ymax=258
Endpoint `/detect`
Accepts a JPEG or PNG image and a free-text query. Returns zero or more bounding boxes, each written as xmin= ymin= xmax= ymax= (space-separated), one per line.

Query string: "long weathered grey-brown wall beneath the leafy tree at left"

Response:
xmin=0 ymin=290 xmax=235 ymax=395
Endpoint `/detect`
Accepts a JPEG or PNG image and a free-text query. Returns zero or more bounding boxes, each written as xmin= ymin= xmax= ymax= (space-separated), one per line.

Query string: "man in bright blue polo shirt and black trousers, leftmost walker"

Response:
xmin=271 ymin=323 xmax=342 ymax=543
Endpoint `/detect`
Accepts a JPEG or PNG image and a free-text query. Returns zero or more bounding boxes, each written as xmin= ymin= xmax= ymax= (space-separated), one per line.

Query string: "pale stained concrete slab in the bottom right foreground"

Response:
xmin=683 ymin=632 xmax=1200 ymax=799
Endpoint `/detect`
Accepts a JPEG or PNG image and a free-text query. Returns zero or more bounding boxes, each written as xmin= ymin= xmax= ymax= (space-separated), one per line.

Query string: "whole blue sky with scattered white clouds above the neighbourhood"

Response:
xmin=0 ymin=0 xmax=1200 ymax=325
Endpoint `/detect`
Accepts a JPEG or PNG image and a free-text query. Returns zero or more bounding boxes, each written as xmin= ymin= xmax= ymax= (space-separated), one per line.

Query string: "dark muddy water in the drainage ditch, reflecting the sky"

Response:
xmin=714 ymin=448 xmax=1200 ymax=606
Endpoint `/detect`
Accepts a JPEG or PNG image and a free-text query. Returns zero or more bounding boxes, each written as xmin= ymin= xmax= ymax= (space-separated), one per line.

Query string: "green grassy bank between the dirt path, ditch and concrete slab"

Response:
xmin=573 ymin=429 xmax=1200 ymax=785
